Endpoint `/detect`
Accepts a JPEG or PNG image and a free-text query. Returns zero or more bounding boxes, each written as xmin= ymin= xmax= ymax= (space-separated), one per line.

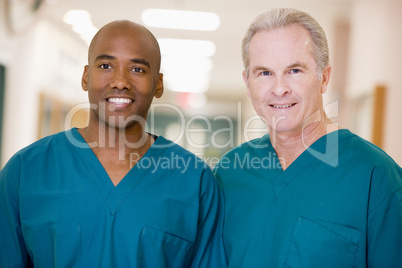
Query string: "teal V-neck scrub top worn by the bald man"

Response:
xmin=0 ymin=129 xmax=226 ymax=268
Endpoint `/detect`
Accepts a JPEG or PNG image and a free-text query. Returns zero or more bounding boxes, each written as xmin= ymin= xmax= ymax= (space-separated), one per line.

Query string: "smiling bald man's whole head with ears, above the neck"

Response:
xmin=82 ymin=21 xmax=163 ymax=128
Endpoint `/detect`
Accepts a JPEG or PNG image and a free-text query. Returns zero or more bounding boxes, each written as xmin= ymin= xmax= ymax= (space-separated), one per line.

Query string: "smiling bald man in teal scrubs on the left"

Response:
xmin=0 ymin=21 xmax=226 ymax=268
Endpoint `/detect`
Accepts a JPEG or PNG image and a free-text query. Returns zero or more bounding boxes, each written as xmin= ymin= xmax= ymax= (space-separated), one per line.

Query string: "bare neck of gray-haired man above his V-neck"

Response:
xmin=269 ymin=113 xmax=338 ymax=170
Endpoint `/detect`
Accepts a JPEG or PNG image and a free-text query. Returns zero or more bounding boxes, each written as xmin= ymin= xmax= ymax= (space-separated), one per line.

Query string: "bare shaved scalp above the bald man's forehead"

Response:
xmin=88 ymin=20 xmax=161 ymax=70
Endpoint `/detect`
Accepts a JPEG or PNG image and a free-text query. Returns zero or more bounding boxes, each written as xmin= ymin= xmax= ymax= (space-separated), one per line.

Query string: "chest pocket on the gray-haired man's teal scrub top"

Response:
xmin=286 ymin=217 xmax=361 ymax=268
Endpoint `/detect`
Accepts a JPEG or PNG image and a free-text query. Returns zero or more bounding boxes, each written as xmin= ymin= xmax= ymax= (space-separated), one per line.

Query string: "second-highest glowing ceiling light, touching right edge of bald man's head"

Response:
xmin=158 ymin=38 xmax=216 ymax=57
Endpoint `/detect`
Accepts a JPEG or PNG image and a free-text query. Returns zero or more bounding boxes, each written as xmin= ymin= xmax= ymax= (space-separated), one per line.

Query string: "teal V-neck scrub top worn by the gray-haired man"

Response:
xmin=214 ymin=130 xmax=402 ymax=268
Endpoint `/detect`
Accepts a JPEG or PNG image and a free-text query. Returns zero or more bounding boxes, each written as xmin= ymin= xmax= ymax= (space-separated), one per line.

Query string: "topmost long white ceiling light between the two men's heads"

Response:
xmin=141 ymin=9 xmax=220 ymax=31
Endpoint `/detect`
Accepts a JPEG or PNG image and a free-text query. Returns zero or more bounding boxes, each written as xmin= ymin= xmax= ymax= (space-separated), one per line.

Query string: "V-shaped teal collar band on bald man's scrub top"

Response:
xmin=71 ymin=128 xmax=167 ymax=214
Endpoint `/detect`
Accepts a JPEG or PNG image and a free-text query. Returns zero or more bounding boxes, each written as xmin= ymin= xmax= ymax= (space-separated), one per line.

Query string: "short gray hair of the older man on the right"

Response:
xmin=242 ymin=8 xmax=329 ymax=79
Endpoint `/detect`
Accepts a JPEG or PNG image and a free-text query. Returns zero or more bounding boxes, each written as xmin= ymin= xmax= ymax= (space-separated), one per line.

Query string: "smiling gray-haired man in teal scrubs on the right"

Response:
xmin=215 ymin=9 xmax=402 ymax=267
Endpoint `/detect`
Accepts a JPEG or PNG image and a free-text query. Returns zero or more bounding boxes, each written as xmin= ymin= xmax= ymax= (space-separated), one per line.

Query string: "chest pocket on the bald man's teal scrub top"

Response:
xmin=138 ymin=226 xmax=192 ymax=268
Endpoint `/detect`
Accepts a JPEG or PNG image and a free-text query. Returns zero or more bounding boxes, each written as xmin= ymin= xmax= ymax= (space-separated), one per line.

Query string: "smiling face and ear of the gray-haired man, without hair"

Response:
xmin=243 ymin=25 xmax=331 ymax=135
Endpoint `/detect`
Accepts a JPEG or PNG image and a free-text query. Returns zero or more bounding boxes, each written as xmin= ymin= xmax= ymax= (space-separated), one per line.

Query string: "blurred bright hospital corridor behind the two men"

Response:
xmin=0 ymin=0 xmax=402 ymax=167
